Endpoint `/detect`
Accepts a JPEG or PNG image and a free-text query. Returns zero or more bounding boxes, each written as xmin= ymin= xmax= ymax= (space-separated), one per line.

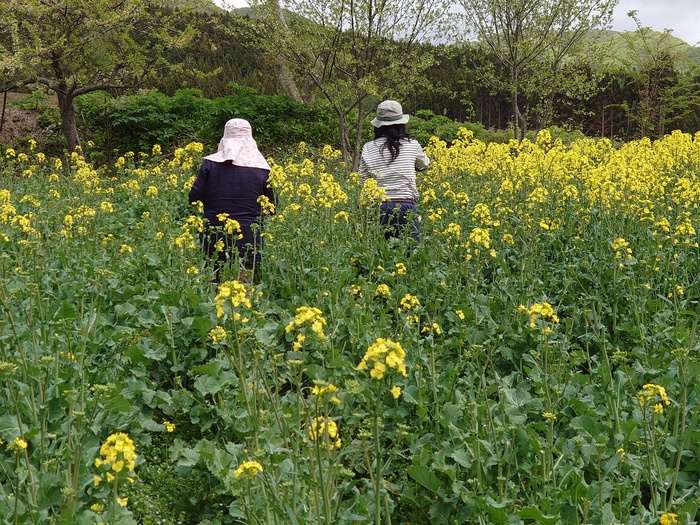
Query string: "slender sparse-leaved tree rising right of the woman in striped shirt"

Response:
xmin=460 ymin=0 xmax=617 ymax=138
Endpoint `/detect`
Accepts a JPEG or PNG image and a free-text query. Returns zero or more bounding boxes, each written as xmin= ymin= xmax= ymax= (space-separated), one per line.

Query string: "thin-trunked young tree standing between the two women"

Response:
xmin=251 ymin=0 xmax=450 ymax=169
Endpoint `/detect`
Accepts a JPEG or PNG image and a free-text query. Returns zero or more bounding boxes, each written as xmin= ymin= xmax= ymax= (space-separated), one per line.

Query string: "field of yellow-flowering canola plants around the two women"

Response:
xmin=0 ymin=130 xmax=700 ymax=525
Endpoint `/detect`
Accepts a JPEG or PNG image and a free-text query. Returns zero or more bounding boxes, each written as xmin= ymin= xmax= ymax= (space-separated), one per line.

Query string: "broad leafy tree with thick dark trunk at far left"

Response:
xmin=0 ymin=0 xmax=201 ymax=151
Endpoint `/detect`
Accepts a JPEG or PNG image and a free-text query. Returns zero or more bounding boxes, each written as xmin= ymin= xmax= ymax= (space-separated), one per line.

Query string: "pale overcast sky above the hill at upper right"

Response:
xmin=223 ymin=0 xmax=700 ymax=46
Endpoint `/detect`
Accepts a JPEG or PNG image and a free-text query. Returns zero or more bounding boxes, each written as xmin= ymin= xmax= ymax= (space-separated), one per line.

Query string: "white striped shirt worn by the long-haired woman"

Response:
xmin=359 ymin=137 xmax=430 ymax=202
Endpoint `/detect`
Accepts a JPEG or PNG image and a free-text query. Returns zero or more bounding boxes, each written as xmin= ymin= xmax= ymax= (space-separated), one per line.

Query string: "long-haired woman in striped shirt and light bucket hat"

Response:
xmin=359 ymin=100 xmax=430 ymax=242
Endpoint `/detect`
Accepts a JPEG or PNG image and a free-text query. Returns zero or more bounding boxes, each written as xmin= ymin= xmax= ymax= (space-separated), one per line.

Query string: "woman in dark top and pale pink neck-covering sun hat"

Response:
xmin=189 ymin=118 xmax=275 ymax=279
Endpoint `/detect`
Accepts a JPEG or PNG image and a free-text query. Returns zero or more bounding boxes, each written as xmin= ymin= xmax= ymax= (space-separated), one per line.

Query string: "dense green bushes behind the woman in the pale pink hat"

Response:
xmin=77 ymin=86 xmax=337 ymax=156
